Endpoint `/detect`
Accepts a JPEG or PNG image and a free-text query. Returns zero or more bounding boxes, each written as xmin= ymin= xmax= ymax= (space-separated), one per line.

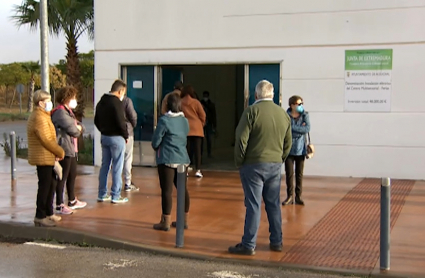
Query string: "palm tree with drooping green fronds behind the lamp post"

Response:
xmin=12 ymin=0 xmax=94 ymax=120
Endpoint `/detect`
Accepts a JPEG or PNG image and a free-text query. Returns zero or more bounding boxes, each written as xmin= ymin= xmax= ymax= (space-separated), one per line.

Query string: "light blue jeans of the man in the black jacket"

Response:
xmin=98 ymin=135 xmax=125 ymax=200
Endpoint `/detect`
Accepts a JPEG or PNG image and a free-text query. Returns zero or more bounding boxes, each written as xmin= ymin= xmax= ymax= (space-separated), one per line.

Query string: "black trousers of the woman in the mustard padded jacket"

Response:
xmin=35 ymin=166 xmax=56 ymax=219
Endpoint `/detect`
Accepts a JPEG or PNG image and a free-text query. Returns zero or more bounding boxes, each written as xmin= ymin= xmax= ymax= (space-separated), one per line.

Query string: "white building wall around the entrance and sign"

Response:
xmin=95 ymin=0 xmax=425 ymax=179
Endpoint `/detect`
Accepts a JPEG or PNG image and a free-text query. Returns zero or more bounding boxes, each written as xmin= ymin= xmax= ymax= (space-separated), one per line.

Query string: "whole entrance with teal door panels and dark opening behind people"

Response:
xmin=121 ymin=62 xmax=282 ymax=171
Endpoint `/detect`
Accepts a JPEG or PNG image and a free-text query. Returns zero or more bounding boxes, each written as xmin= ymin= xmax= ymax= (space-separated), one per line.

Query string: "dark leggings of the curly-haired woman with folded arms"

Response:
xmin=56 ymin=156 xmax=77 ymax=206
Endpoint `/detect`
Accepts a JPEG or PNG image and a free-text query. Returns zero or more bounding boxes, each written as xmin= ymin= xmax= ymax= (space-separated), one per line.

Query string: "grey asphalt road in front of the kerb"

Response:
xmin=0 ymin=240 xmax=354 ymax=278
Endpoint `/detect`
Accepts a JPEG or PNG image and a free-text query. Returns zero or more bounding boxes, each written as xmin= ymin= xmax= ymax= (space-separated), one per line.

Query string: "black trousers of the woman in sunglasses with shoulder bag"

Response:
xmin=285 ymin=155 xmax=305 ymax=198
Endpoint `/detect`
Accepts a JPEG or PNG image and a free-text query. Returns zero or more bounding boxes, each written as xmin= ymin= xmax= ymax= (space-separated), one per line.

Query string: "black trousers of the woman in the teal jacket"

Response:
xmin=158 ymin=164 xmax=190 ymax=215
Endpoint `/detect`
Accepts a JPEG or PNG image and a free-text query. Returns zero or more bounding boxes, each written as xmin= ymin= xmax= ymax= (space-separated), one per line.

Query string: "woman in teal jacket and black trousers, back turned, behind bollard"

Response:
xmin=152 ymin=93 xmax=190 ymax=231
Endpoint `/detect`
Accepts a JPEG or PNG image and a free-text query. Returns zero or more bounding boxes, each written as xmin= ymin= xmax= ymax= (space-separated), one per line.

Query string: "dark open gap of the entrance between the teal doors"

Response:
xmin=161 ymin=65 xmax=245 ymax=170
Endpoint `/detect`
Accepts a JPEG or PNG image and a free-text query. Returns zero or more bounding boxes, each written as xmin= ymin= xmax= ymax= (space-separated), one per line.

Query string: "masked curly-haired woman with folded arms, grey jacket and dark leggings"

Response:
xmin=52 ymin=86 xmax=87 ymax=214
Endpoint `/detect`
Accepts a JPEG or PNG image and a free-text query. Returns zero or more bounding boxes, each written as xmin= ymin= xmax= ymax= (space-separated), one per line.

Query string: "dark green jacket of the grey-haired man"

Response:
xmin=235 ymin=99 xmax=292 ymax=167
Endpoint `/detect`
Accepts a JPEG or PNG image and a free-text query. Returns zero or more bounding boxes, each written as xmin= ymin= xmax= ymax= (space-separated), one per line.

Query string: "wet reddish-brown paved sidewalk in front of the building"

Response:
xmin=0 ymin=157 xmax=425 ymax=277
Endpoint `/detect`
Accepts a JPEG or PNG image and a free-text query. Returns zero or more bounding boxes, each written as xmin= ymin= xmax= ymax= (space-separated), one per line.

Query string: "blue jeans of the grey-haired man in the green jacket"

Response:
xmin=239 ymin=163 xmax=282 ymax=249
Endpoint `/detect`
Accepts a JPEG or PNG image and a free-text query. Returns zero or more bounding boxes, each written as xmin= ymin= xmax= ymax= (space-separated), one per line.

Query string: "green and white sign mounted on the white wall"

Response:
xmin=344 ymin=49 xmax=393 ymax=112
